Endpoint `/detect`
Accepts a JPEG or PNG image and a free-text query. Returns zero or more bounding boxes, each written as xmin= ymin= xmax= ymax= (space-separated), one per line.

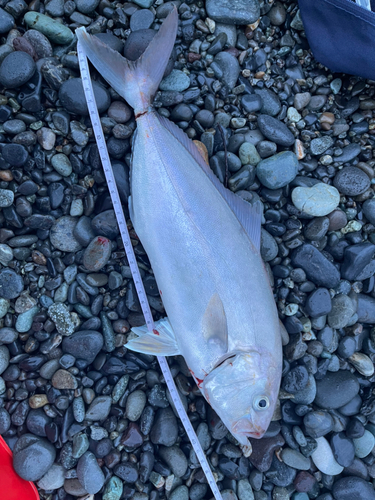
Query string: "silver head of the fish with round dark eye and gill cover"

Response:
xmin=202 ymin=350 xmax=282 ymax=445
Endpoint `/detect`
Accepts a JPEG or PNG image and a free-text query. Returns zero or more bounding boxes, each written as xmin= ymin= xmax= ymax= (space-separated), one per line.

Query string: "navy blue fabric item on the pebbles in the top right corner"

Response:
xmin=298 ymin=0 xmax=375 ymax=80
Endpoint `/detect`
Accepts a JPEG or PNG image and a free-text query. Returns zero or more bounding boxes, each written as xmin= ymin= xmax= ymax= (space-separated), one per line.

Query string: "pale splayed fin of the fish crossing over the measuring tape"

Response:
xmin=125 ymin=318 xmax=180 ymax=356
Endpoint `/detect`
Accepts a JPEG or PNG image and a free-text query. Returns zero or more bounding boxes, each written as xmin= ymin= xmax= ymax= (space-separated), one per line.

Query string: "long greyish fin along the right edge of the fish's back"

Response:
xmin=156 ymin=113 xmax=262 ymax=251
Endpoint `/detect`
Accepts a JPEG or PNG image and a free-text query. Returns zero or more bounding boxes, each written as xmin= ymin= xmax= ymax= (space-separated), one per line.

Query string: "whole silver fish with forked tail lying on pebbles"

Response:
xmin=76 ymin=9 xmax=282 ymax=445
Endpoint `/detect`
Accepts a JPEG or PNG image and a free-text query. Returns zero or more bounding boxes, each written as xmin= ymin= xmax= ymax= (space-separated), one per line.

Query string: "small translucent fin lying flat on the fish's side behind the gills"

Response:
xmin=202 ymin=293 xmax=228 ymax=354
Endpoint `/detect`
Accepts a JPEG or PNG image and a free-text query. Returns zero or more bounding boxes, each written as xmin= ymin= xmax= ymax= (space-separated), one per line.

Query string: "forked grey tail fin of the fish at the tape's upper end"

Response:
xmin=76 ymin=8 xmax=178 ymax=117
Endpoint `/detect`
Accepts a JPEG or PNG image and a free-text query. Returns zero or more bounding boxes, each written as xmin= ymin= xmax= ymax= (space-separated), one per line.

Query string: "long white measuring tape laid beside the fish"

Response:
xmin=77 ymin=43 xmax=223 ymax=500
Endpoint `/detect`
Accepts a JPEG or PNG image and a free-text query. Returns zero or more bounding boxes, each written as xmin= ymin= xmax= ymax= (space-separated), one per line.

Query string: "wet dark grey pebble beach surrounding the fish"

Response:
xmin=0 ymin=0 xmax=375 ymax=500
